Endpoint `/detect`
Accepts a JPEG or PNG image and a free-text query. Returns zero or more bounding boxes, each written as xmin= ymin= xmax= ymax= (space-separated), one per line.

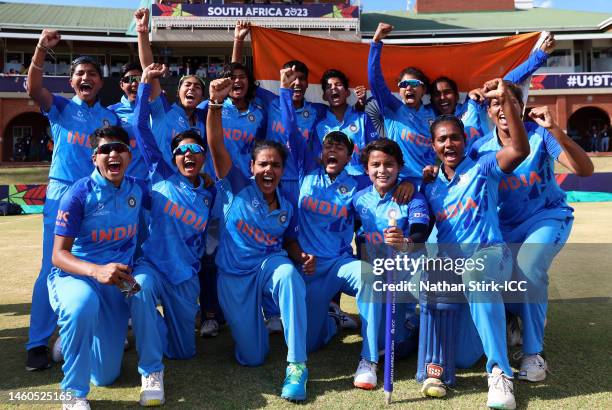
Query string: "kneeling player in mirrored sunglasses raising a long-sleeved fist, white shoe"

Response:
xmin=130 ymin=64 xmax=212 ymax=406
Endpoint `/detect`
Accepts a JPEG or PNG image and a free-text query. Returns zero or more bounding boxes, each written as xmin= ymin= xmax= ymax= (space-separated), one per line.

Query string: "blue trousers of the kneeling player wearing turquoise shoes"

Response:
xmin=217 ymin=255 xmax=306 ymax=366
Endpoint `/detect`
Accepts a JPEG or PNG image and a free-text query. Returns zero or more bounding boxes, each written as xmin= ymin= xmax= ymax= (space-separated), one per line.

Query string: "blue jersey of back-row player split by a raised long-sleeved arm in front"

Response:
xmin=257 ymin=87 xmax=327 ymax=181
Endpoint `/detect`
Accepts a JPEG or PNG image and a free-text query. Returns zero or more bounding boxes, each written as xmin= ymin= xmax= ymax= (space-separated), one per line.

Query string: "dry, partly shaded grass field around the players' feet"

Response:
xmin=0 ymin=207 xmax=612 ymax=409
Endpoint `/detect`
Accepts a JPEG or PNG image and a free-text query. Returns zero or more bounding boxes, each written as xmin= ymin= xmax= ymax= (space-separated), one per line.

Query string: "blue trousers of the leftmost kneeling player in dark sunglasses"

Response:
xmin=48 ymin=268 xmax=129 ymax=397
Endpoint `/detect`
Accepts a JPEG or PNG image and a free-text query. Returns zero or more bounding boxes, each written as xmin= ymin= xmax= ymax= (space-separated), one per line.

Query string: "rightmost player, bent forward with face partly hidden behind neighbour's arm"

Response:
xmin=471 ymin=101 xmax=593 ymax=382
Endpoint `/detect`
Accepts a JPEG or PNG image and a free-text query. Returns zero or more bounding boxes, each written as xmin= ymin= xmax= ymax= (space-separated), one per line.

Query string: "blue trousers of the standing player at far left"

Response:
xmin=26 ymin=179 xmax=70 ymax=350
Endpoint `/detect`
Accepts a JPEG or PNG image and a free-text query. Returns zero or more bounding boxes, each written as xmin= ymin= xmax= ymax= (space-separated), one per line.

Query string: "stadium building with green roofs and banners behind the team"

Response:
xmin=0 ymin=0 xmax=612 ymax=164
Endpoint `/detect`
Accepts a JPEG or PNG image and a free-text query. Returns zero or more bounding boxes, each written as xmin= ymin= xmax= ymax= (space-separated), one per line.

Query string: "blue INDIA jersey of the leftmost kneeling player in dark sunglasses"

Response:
xmin=55 ymin=169 xmax=150 ymax=269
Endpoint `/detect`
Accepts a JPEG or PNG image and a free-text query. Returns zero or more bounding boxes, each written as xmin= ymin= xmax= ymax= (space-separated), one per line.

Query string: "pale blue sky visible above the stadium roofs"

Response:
xmin=4 ymin=0 xmax=612 ymax=14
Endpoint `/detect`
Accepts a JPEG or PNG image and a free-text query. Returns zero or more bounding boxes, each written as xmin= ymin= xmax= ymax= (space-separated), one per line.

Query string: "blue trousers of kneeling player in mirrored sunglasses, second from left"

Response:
xmin=129 ymin=259 xmax=200 ymax=376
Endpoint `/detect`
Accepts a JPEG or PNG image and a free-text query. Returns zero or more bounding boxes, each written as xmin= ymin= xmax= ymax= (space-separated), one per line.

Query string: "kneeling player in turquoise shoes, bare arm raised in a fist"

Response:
xmin=206 ymin=78 xmax=310 ymax=401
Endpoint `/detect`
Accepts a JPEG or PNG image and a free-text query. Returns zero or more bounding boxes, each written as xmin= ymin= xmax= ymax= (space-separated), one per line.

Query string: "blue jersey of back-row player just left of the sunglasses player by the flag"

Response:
xmin=314 ymin=105 xmax=378 ymax=175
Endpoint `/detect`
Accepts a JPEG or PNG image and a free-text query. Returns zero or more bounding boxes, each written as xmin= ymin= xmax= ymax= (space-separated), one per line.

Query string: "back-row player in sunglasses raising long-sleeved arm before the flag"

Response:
xmin=368 ymin=23 xmax=435 ymax=185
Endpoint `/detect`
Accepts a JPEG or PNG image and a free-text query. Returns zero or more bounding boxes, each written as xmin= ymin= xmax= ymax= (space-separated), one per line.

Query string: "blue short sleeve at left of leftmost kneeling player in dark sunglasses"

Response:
xmin=55 ymin=182 xmax=87 ymax=238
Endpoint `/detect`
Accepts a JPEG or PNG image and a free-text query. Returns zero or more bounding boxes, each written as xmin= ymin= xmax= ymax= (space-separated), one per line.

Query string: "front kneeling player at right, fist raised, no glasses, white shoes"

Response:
xmin=417 ymin=79 xmax=529 ymax=409
